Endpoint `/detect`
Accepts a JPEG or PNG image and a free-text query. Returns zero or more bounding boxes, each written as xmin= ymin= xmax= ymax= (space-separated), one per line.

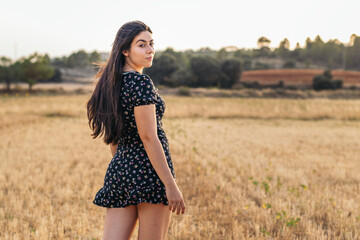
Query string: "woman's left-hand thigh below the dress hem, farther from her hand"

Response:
xmin=103 ymin=205 xmax=138 ymax=240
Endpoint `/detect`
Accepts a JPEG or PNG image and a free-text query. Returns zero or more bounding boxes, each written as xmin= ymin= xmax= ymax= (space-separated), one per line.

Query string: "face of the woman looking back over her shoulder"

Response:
xmin=123 ymin=31 xmax=155 ymax=73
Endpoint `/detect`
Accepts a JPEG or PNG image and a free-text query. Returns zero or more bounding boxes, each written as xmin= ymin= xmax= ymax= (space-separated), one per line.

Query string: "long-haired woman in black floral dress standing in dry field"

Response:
xmin=87 ymin=21 xmax=185 ymax=240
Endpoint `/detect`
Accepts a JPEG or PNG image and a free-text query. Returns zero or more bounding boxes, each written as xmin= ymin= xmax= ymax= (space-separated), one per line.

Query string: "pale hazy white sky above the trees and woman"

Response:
xmin=0 ymin=0 xmax=360 ymax=59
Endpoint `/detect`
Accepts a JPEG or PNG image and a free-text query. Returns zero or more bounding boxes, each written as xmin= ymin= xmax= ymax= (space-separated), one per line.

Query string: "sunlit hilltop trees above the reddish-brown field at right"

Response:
xmin=253 ymin=34 xmax=360 ymax=70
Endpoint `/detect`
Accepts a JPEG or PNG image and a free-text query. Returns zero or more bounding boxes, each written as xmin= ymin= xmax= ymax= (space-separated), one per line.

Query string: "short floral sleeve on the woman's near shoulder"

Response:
xmin=131 ymin=75 xmax=158 ymax=107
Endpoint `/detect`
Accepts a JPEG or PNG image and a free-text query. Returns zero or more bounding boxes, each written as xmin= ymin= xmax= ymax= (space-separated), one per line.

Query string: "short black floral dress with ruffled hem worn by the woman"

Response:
xmin=93 ymin=71 xmax=175 ymax=208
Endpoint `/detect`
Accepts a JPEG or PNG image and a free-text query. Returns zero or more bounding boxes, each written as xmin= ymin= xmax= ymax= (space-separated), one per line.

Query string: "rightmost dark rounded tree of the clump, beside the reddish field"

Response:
xmin=220 ymin=59 xmax=242 ymax=88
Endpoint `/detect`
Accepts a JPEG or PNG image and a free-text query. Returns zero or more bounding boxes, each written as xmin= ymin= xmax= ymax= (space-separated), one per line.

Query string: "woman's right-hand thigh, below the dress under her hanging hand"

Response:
xmin=137 ymin=203 xmax=171 ymax=240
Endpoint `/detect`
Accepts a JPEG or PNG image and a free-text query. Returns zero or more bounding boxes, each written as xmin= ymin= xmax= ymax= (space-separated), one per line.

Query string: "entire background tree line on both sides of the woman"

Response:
xmin=0 ymin=34 xmax=360 ymax=90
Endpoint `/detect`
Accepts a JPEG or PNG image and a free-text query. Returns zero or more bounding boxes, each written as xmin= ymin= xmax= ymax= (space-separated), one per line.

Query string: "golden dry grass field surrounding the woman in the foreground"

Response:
xmin=0 ymin=95 xmax=360 ymax=240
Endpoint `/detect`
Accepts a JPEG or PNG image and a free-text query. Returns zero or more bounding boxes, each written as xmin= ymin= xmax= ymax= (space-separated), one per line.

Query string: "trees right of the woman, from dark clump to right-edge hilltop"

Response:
xmin=145 ymin=34 xmax=360 ymax=90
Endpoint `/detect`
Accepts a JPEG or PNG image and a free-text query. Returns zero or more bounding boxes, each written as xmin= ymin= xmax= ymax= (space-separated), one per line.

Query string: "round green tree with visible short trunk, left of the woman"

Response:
xmin=21 ymin=52 xmax=55 ymax=91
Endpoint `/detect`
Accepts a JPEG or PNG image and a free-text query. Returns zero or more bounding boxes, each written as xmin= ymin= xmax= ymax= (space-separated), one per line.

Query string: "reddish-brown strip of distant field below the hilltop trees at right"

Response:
xmin=241 ymin=69 xmax=360 ymax=87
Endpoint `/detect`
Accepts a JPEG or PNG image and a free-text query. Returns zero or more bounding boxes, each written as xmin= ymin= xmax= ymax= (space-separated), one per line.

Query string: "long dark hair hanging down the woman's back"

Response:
xmin=87 ymin=21 xmax=152 ymax=144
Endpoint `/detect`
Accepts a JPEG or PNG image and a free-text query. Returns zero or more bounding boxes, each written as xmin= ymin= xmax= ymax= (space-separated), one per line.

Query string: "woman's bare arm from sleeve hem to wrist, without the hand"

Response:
xmin=134 ymin=104 xmax=176 ymax=188
